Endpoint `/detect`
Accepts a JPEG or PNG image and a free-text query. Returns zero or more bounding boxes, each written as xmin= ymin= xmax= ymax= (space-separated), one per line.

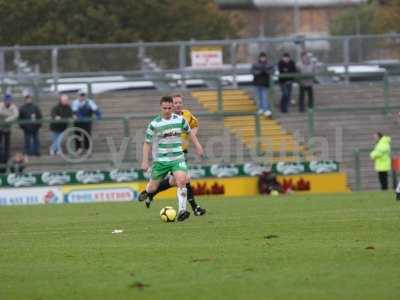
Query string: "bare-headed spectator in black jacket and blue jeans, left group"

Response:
xmin=50 ymin=94 xmax=73 ymax=155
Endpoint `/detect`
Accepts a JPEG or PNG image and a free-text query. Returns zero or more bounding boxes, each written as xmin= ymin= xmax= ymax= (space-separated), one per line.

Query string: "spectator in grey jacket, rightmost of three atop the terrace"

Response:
xmin=297 ymin=52 xmax=316 ymax=112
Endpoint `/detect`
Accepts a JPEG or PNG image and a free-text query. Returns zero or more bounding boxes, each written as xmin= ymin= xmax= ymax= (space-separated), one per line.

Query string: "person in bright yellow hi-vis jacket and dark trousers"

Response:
xmin=369 ymin=132 xmax=391 ymax=190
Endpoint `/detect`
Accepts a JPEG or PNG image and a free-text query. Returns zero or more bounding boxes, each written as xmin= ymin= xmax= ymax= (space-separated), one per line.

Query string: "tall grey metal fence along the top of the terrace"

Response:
xmin=0 ymin=34 xmax=400 ymax=82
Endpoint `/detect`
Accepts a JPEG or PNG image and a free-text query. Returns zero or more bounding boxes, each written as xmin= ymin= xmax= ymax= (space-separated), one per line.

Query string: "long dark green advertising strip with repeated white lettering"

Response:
xmin=0 ymin=161 xmax=339 ymax=188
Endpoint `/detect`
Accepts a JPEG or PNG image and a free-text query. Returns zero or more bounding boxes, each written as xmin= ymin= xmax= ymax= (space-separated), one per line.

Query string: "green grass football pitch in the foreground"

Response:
xmin=0 ymin=192 xmax=400 ymax=300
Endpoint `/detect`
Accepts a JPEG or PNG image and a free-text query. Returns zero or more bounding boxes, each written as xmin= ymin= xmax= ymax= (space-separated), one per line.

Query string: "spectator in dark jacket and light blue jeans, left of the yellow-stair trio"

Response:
xmin=251 ymin=52 xmax=273 ymax=117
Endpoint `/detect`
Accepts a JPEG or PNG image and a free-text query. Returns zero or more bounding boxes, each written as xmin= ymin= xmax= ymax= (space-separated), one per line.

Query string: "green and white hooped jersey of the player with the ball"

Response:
xmin=145 ymin=114 xmax=190 ymax=162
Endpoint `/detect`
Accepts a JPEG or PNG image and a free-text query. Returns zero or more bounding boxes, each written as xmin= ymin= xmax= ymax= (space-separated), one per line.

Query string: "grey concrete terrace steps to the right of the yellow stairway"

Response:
xmin=276 ymin=83 xmax=400 ymax=189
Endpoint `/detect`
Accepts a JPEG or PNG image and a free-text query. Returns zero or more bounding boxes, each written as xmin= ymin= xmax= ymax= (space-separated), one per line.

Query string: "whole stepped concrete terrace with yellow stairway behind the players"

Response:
xmin=3 ymin=78 xmax=400 ymax=189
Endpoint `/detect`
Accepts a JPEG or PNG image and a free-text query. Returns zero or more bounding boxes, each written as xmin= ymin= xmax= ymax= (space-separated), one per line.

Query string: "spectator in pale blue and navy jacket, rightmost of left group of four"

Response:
xmin=72 ymin=90 xmax=101 ymax=151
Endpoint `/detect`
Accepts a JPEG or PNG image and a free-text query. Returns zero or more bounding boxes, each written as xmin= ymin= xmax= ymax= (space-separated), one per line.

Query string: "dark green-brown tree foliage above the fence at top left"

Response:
xmin=0 ymin=0 xmax=236 ymax=45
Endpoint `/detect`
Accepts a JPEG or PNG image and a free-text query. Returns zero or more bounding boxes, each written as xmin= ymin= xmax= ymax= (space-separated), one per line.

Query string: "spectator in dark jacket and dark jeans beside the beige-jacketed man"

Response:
xmin=19 ymin=92 xmax=42 ymax=156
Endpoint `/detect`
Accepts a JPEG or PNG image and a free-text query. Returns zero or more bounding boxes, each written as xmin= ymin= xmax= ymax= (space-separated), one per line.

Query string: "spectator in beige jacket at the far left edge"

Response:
xmin=0 ymin=94 xmax=18 ymax=173
